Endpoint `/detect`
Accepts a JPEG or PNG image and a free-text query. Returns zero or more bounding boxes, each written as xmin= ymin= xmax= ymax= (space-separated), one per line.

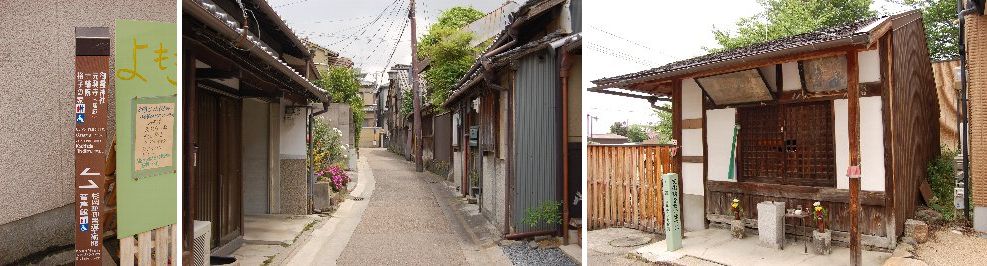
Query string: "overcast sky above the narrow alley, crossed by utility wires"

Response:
xmin=270 ymin=0 xmax=510 ymax=83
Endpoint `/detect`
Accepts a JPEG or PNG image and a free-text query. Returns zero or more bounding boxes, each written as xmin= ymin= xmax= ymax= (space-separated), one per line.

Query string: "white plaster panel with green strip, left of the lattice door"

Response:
xmin=706 ymin=108 xmax=737 ymax=182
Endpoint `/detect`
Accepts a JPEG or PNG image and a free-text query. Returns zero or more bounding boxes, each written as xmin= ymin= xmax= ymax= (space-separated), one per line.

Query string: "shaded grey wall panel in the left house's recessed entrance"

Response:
xmin=242 ymin=99 xmax=271 ymax=214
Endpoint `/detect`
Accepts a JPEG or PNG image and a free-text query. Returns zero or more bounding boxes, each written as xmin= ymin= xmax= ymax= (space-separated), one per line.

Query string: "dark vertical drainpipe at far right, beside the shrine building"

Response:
xmin=956 ymin=0 xmax=976 ymax=221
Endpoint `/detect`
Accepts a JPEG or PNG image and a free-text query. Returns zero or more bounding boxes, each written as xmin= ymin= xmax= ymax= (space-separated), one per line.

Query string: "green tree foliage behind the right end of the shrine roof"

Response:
xmin=904 ymin=0 xmax=960 ymax=60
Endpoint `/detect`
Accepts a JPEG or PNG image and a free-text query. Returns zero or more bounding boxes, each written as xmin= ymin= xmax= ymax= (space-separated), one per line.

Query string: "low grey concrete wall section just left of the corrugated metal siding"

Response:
xmin=480 ymin=155 xmax=507 ymax=233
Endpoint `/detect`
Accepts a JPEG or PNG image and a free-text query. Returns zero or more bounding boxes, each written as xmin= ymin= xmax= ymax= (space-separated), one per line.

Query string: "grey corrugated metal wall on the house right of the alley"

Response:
xmin=511 ymin=52 xmax=561 ymax=233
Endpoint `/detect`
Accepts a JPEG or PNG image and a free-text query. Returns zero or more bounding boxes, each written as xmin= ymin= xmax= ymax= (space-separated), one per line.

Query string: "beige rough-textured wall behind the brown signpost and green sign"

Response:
xmin=0 ymin=0 xmax=177 ymax=264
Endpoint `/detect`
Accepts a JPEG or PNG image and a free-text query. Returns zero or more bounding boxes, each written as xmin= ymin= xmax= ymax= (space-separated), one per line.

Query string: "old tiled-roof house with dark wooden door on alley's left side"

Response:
xmin=182 ymin=0 xmax=329 ymax=258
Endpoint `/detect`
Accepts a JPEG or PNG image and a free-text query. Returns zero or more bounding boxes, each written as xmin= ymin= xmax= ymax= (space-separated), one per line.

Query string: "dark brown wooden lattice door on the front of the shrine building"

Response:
xmin=737 ymin=101 xmax=836 ymax=187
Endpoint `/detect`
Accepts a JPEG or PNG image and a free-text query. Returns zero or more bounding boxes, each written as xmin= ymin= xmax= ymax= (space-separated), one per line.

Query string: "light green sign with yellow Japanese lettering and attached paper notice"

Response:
xmin=114 ymin=20 xmax=179 ymax=238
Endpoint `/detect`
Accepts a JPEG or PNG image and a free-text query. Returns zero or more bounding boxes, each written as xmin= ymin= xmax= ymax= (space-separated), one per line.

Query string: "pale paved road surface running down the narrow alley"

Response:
xmin=336 ymin=149 xmax=469 ymax=265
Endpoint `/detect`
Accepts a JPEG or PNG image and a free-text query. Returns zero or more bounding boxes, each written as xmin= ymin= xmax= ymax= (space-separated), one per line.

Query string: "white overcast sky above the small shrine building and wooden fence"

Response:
xmin=583 ymin=0 xmax=905 ymax=133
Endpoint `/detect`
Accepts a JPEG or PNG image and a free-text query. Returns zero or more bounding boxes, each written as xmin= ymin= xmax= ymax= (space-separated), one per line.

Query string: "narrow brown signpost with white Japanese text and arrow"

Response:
xmin=73 ymin=27 xmax=111 ymax=265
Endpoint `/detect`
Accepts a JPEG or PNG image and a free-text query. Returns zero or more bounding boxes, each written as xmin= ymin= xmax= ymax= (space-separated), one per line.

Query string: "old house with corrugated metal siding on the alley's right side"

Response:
xmin=443 ymin=0 xmax=582 ymax=241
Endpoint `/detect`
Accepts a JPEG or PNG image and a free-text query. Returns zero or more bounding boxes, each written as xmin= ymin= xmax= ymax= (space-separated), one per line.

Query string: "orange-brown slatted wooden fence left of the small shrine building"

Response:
xmin=586 ymin=145 xmax=672 ymax=233
